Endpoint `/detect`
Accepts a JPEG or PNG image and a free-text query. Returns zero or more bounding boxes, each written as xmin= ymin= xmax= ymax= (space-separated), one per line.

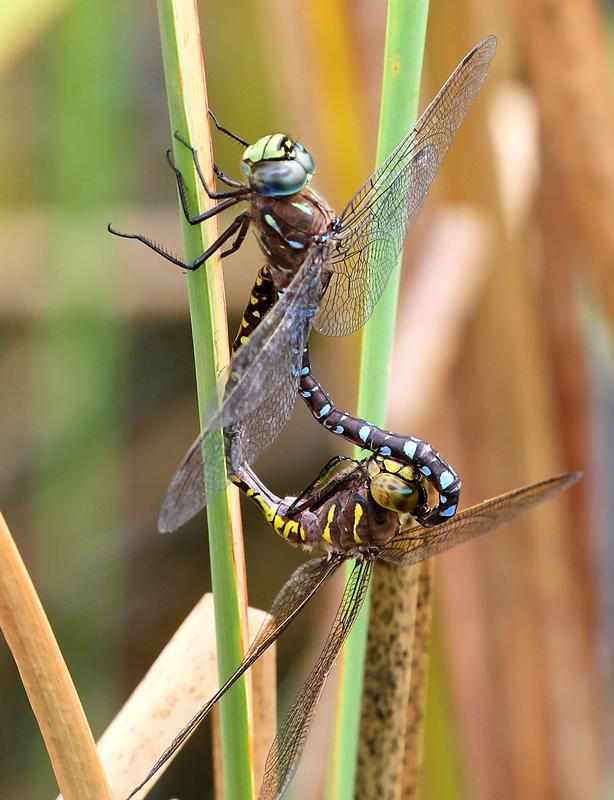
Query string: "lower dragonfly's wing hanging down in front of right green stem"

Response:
xmin=258 ymin=561 xmax=373 ymax=800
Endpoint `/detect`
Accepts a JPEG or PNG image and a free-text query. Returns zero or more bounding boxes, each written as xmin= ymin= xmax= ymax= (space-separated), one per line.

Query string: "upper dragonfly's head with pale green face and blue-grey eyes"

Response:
xmin=241 ymin=133 xmax=316 ymax=197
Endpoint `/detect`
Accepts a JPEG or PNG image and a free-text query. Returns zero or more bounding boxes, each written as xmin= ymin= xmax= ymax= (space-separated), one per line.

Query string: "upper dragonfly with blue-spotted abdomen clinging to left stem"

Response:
xmin=110 ymin=36 xmax=496 ymax=530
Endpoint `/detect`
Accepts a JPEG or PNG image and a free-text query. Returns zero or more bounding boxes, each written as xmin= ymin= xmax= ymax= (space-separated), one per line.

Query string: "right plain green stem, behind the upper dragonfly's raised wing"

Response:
xmin=328 ymin=0 xmax=428 ymax=800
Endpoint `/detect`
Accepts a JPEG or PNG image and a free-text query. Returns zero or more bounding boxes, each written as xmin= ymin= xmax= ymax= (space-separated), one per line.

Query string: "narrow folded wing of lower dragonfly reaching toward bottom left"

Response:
xmin=122 ymin=558 xmax=342 ymax=800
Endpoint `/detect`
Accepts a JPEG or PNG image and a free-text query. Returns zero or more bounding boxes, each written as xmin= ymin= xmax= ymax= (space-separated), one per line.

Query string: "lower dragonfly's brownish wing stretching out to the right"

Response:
xmin=379 ymin=472 xmax=581 ymax=567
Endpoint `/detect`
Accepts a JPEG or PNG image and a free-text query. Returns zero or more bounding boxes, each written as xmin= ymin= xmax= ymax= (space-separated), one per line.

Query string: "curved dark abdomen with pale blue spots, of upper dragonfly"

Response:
xmin=299 ymin=347 xmax=461 ymax=525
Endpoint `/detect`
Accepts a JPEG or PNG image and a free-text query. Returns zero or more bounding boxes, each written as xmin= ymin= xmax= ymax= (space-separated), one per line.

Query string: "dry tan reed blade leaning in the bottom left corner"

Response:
xmin=0 ymin=514 xmax=113 ymax=800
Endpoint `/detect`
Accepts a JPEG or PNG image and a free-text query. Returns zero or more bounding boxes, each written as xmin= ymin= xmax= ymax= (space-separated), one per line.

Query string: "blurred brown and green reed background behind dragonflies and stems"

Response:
xmin=0 ymin=0 xmax=614 ymax=800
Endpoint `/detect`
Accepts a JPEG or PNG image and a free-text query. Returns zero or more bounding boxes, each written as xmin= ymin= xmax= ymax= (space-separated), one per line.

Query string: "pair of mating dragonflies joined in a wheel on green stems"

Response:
xmin=109 ymin=37 xmax=578 ymax=800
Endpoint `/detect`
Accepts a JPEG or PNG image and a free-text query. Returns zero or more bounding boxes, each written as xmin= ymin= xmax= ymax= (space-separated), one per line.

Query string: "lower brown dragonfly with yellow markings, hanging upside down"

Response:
xmin=128 ymin=454 xmax=580 ymax=800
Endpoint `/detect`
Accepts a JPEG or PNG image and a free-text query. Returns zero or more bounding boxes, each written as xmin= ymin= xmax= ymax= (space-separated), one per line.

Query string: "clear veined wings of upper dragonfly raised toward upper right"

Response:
xmin=314 ymin=36 xmax=497 ymax=336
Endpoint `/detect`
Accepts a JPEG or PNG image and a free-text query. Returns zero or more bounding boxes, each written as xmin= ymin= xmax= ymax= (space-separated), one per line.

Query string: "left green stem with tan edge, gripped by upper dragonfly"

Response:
xmin=158 ymin=0 xmax=253 ymax=800
